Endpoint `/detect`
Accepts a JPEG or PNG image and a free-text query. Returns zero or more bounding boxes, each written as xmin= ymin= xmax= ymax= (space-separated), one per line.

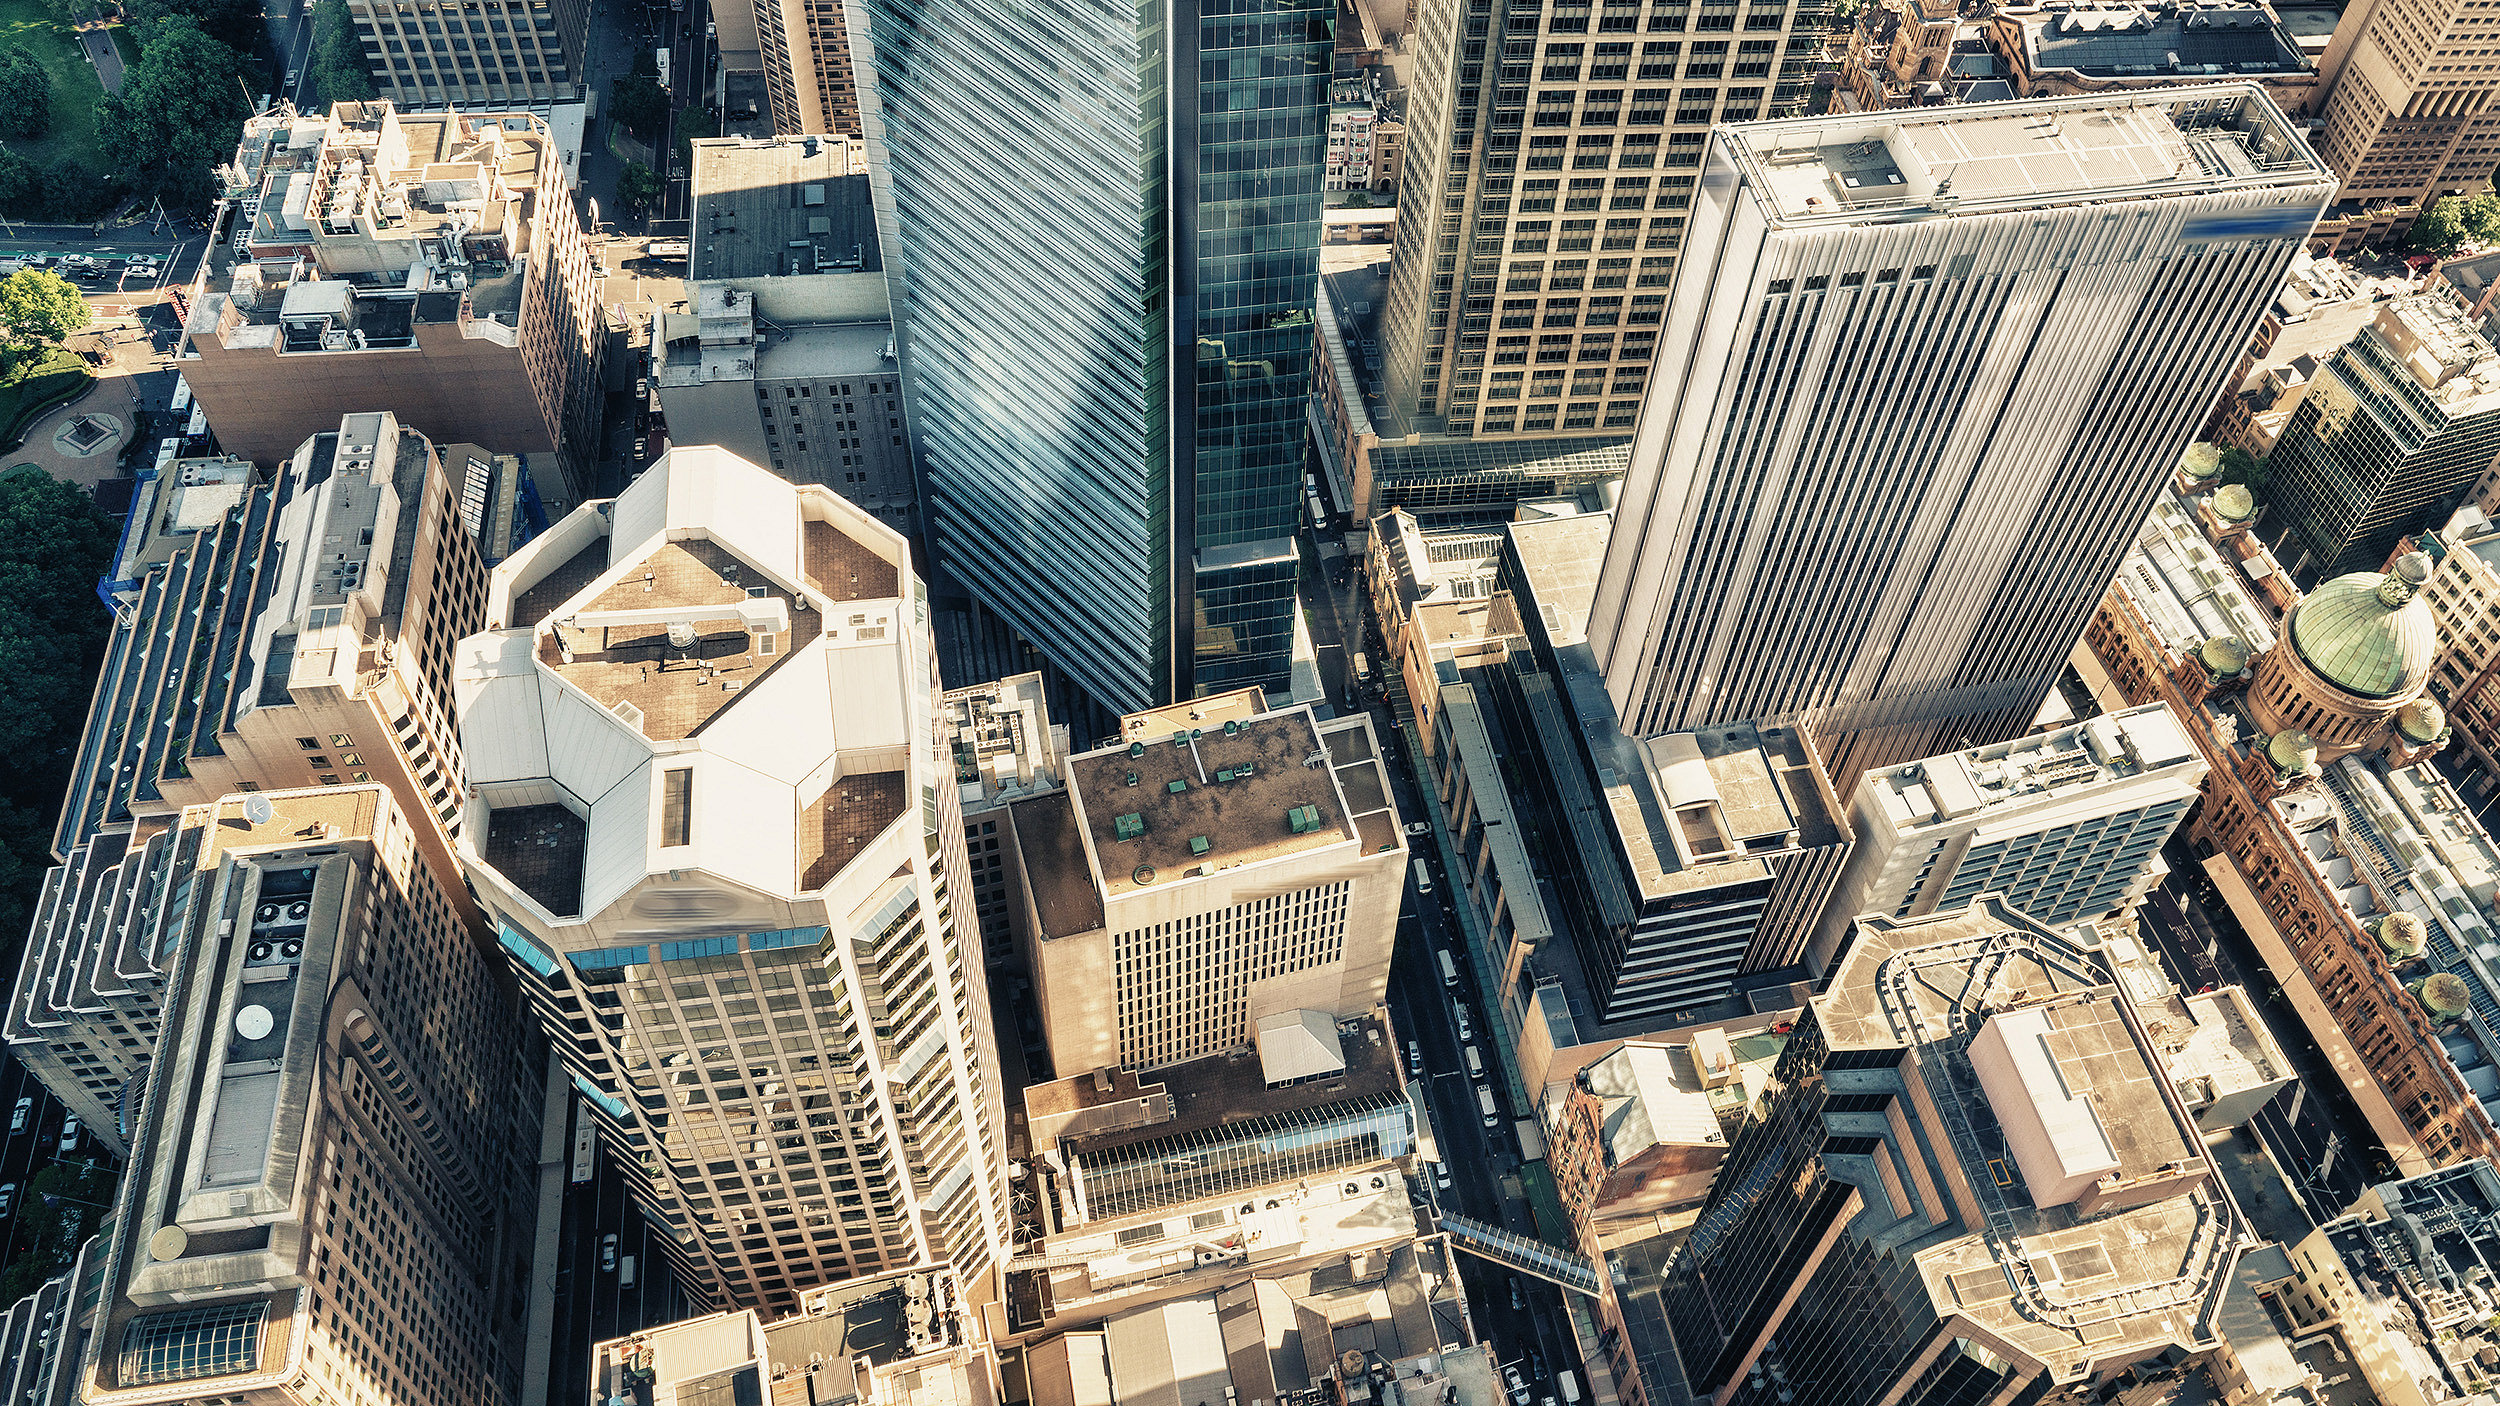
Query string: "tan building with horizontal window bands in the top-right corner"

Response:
xmin=2310 ymin=0 xmax=2500 ymax=205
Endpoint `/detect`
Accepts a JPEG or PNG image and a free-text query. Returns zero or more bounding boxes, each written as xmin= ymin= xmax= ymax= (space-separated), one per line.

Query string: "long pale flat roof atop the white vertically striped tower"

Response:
xmin=1710 ymin=83 xmax=2335 ymax=228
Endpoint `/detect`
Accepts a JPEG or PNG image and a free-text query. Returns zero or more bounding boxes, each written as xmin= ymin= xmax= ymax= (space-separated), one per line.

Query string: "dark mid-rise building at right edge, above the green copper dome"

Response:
xmin=2260 ymin=293 xmax=2500 ymax=580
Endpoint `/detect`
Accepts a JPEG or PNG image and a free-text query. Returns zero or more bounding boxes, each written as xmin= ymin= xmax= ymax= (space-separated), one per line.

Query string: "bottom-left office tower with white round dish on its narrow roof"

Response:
xmin=78 ymin=786 xmax=545 ymax=1406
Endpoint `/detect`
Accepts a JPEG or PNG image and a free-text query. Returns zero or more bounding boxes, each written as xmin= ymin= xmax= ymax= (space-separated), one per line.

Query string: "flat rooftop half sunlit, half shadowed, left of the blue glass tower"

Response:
xmin=688 ymin=138 xmax=885 ymax=283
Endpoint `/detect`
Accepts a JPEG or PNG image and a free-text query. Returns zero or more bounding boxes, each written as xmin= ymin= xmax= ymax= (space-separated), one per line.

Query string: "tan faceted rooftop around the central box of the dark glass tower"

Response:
xmin=1813 ymin=906 xmax=2243 ymax=1368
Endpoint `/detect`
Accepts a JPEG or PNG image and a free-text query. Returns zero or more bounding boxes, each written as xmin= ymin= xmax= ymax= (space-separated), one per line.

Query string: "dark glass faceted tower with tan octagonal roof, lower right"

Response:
xmin=1653 ymin=901 xmax=2250 ymax=1406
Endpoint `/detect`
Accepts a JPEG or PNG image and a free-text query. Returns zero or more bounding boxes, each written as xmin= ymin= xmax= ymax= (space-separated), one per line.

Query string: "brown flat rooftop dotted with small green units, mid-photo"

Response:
xmin=1068 ymin=708 xmax=1358 ymax=898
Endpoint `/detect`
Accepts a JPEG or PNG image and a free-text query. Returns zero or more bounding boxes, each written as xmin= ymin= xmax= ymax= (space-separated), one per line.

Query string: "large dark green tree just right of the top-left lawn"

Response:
xmin=95 ymin=15 xmax=250 ymax=205
